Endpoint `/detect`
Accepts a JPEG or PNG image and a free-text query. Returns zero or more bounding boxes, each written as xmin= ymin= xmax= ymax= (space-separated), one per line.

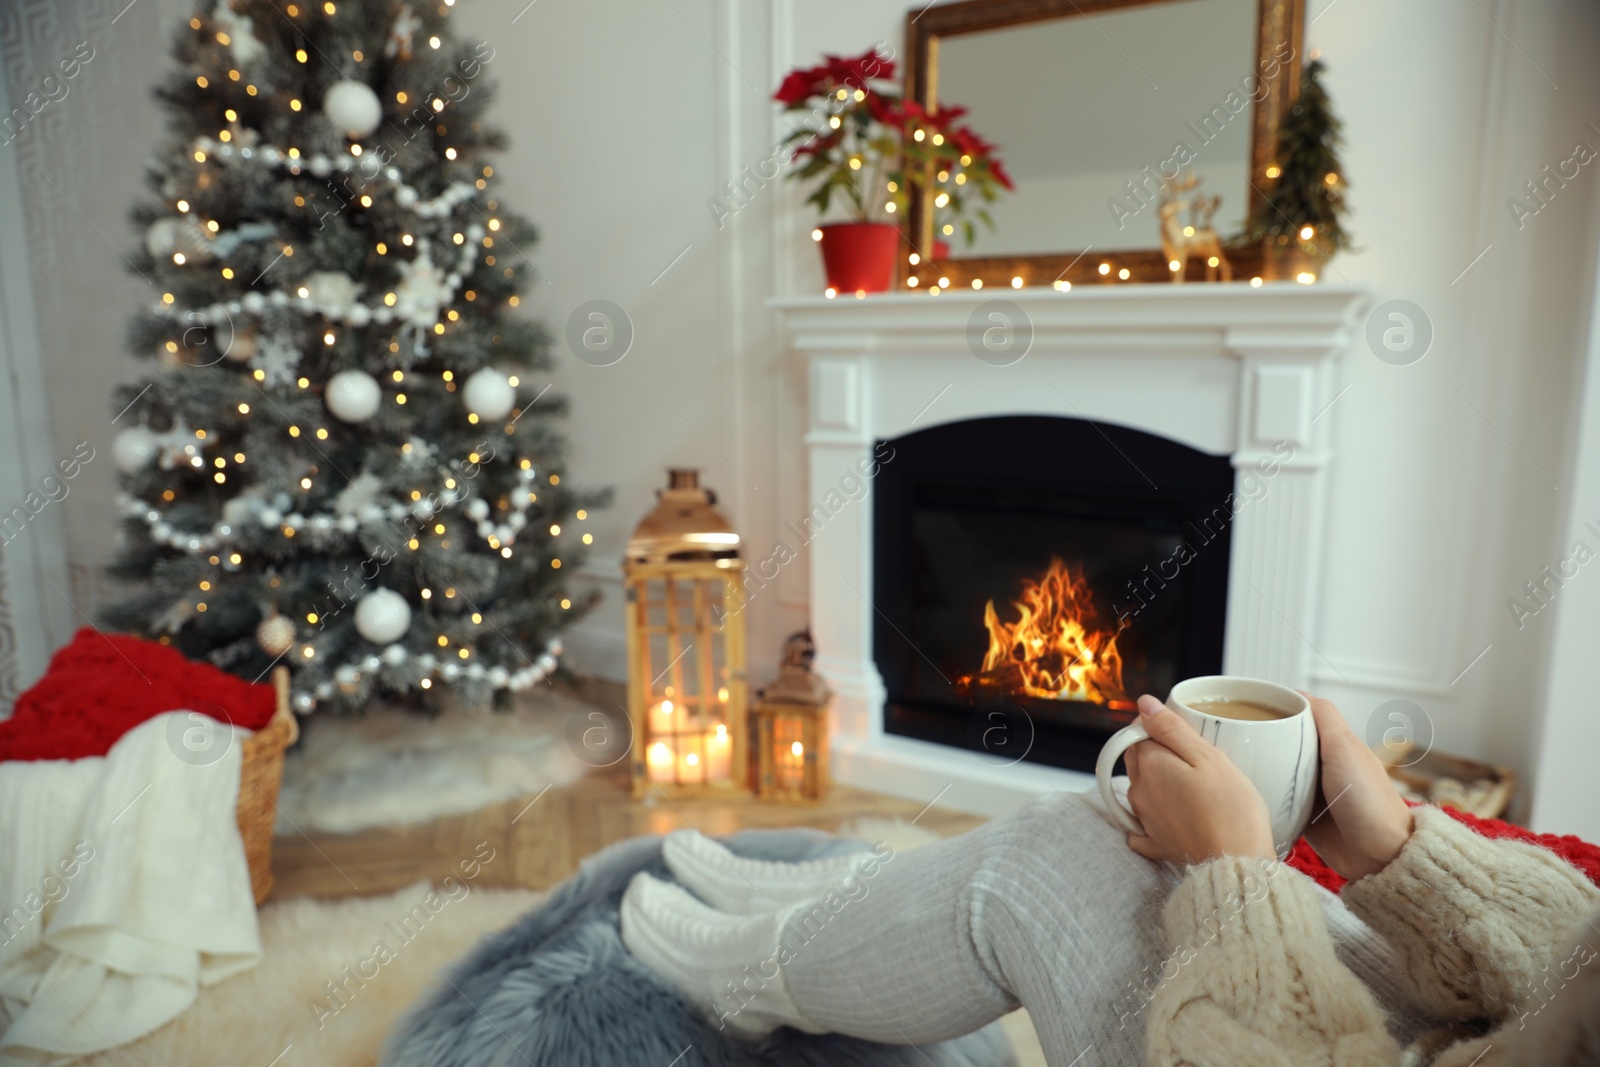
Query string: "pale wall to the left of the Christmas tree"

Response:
xmin=0 ymin=0 xmax=190 ymax=689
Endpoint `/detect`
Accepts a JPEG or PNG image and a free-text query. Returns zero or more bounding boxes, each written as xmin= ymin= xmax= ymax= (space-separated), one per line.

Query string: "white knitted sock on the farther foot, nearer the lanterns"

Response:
xmin=661 ymin=830 xmax=872 ymax=915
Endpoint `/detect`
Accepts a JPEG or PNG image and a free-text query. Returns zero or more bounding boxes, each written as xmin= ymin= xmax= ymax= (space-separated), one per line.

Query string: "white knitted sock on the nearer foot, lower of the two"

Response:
xmin=622 ymin=873 xmax=822 ymax=1037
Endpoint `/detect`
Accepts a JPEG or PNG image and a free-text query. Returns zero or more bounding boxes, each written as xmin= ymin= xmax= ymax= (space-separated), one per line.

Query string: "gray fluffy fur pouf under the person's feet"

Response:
xmin=381 ymin=830 xmax=1014 ymax=1067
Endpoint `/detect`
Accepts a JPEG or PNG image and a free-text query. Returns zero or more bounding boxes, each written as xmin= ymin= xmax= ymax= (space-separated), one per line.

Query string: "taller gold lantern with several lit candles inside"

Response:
xmin=622 ymin=470 xmax=749 ymax=797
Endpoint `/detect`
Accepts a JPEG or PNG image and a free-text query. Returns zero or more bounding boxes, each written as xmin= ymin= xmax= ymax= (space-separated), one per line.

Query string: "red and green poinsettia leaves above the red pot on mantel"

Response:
xmin=773 ymin=48 xmax=1013 ymax=243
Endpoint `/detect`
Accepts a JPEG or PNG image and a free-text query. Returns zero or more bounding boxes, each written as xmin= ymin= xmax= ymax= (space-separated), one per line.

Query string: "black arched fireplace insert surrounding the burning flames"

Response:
xmin=872 ymin=416 xmax=1237 ymax=771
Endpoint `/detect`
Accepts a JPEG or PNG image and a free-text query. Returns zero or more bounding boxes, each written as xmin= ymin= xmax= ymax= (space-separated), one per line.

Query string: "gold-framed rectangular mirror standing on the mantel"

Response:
xmin=899 ymin=0 xmax=1304 ymax=288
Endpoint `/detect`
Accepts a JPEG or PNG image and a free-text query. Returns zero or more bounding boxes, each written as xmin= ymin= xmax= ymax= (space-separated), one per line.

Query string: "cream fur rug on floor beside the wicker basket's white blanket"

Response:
xmin=80 ymin=881 xmax=544 ymax=1067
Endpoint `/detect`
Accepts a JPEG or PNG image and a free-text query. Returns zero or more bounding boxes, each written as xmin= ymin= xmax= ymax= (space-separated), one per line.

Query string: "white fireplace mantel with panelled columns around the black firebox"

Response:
xmin=773 ymin=283 xmax=1370 ymax=814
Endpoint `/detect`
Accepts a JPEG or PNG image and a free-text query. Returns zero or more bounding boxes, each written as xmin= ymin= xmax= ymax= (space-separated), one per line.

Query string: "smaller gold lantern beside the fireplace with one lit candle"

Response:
xmin=752 ymin=632 xmax=832 ymax=803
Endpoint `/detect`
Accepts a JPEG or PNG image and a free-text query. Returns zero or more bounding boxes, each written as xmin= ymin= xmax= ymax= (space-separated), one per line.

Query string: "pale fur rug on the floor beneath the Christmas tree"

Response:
xmin=278 ymin=688 xmax=611 ymax=833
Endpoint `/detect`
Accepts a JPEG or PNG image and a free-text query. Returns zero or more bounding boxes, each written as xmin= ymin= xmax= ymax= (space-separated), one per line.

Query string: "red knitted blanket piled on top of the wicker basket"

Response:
xmin=0 ymin=629 xmax=277 ymax=760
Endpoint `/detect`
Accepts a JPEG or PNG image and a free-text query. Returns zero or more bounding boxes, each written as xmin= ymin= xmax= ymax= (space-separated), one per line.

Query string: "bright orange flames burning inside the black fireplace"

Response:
xmin=962 ymin=560 xmax=1133 ymax=709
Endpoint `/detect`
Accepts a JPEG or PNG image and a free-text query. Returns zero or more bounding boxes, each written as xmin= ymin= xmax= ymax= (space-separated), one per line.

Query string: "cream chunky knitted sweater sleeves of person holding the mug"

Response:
xmin=1146 ymin=808 xmax=1600 ymax=1067
